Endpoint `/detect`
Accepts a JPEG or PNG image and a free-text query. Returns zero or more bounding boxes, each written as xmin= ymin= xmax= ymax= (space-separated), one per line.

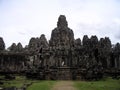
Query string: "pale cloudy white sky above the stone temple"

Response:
xmin=0 ymin=0 xmax=120 ymax=47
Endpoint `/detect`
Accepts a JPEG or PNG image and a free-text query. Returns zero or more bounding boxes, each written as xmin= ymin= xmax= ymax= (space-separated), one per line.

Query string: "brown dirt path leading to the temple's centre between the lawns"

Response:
xmin=52 ymin=81 xmax=75 ymax=90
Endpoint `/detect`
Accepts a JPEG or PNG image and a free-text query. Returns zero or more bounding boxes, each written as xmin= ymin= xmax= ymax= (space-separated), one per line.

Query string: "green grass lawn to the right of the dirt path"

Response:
xmin=74 ymin=78 xmax=120 ymax=90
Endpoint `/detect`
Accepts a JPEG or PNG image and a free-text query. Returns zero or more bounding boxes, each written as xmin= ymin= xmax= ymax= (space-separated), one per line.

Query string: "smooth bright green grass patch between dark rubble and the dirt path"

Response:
xmin=27 ymin=81 xmax=56 ymax=90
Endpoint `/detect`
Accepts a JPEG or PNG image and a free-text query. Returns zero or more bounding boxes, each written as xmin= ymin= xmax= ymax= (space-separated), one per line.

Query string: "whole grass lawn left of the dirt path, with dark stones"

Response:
xmin=0 ymin=76 xmax=57 ymax=90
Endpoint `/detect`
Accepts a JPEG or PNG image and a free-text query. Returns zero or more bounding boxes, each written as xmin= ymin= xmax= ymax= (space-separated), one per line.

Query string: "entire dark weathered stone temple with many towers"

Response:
xmin=0 ymin=15 xmax=120 ymax=80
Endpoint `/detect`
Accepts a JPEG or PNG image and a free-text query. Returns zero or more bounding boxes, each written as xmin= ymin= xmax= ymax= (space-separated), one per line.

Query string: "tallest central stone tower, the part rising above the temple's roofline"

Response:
xmin=50 ymin=15 xmax=74 ymax=48
